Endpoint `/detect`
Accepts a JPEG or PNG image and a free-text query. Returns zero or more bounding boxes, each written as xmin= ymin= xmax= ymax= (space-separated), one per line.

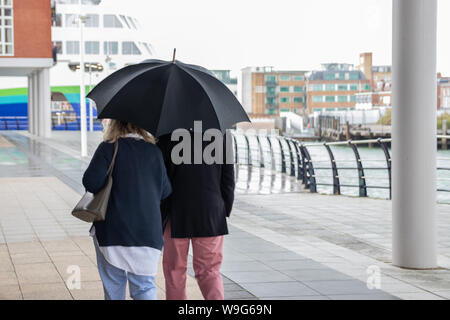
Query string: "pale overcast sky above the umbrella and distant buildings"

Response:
xmin=118 ymin=0 xmax=450 ymax=76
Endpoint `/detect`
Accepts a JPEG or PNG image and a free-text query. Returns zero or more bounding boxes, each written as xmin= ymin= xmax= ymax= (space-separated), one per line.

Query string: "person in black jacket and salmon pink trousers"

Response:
xmin=158 ymin=136 xmax=235 ymax=300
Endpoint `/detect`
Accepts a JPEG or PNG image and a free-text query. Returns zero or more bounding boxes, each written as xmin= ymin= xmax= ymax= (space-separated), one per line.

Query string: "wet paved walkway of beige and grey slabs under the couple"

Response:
xmin=0 ymin=132 xmax=450 ymax=299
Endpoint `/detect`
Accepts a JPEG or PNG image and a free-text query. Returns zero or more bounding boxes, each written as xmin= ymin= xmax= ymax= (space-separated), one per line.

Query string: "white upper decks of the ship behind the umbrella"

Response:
xmin=50 ymin=0 xmax=153 ymax=86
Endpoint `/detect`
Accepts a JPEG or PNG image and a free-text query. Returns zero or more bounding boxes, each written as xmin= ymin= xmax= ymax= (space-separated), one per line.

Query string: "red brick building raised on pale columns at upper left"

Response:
xmin=0 ymin=0 xmax=53 ymax=136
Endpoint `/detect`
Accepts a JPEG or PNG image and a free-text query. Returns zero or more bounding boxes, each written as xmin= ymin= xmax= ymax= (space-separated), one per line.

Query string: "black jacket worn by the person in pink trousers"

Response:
xmin=158 ymin=136 xmax=235 ymax=238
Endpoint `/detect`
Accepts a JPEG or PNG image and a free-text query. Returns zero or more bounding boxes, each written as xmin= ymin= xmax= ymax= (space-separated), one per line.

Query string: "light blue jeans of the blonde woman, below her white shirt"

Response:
xmin=95 ymin=242 xmax=158 ymax=300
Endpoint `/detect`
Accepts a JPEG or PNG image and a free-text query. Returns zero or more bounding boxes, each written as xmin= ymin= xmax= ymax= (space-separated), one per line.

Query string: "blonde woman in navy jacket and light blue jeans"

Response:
xmin=83 ymin=120 xmax=171 ymax=300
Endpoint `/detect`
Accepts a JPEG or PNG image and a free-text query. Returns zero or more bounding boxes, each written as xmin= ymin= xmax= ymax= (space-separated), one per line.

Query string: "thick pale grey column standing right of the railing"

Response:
xmin=392 ymin=0 xmax=437 ymax=269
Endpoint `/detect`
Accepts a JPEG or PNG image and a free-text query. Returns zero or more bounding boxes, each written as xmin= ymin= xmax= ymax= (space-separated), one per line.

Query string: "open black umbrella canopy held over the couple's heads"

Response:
xmin=87 ymin=59 xmax=250 ymax=137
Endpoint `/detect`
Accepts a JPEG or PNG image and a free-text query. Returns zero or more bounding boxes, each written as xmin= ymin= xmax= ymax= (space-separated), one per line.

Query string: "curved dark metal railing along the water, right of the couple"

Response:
xmin=232 ymin=131 xmax=450 ymax=199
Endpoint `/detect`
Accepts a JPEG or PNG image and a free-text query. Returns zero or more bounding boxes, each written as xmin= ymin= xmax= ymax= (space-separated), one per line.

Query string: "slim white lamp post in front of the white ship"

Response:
xmin=79 ymin=1 xmax=87 ymax=157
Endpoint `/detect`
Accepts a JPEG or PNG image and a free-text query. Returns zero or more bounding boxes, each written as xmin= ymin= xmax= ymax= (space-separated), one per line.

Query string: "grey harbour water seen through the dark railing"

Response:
xmin=237 ymin=136 xmax=450 ymax=203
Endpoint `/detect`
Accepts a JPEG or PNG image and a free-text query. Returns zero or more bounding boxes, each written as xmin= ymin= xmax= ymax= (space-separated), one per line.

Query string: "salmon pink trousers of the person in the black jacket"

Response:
xmin=163 ymin=224 xmax=223 ymax=300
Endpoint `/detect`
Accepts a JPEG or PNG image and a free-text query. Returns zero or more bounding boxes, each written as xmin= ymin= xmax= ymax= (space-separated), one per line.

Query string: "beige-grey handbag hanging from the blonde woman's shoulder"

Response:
xmin=72 ymin=140 xmax=119 ymax=222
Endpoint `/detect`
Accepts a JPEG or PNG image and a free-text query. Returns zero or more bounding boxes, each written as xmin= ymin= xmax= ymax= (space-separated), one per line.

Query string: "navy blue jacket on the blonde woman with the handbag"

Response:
xmin=83 ymin=138 xmax=171 ymax=250
